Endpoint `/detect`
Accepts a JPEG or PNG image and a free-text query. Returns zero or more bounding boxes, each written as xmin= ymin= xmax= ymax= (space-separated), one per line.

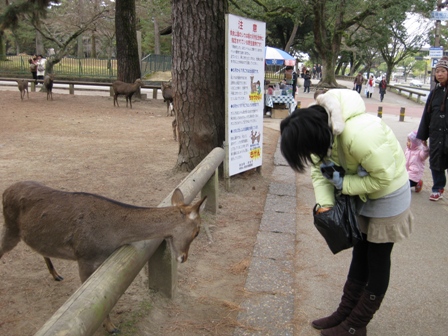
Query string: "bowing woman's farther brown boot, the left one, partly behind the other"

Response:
xmin=311 ymin=279 xmax=366 ymax=329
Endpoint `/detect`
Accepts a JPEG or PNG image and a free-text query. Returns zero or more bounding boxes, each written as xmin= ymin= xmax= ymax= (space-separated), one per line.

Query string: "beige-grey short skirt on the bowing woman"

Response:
xmin=358 ymin=208 xmax=414 ymax=243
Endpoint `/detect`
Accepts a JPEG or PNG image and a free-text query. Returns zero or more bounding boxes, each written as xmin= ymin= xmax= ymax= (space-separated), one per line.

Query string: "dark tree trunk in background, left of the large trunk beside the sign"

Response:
xmin=115 ymin=0 xmax=141 ymax=82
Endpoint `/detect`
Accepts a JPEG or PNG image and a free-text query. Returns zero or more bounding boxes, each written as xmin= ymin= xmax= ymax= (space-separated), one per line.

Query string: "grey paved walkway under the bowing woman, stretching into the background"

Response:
xmin=234 ymin=84 xmax=448 ymax=336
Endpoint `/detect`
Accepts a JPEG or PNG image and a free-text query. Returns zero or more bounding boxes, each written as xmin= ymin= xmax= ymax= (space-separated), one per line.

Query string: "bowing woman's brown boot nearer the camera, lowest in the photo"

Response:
xmin=321 ymin=290 xmax=384 ymax=336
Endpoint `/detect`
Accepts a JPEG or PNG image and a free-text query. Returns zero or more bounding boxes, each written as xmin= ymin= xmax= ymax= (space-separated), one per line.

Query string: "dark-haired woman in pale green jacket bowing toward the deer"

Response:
xmin=280 ymin=90 xmax=412 ymax=336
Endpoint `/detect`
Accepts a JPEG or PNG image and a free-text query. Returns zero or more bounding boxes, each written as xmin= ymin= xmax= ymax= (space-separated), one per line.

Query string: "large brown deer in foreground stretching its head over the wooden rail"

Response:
xmin=0 ymin=181 xmax=207 ymax=333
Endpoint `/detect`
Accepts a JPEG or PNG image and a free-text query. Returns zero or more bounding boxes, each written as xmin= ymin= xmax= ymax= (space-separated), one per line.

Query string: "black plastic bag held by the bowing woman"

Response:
xmin=313 ymin=193 xmax=362 ymax=254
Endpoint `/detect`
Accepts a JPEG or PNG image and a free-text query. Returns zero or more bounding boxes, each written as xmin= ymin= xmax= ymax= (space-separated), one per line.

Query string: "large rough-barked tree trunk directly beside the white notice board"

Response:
xmin=172 ymin=0 xmax=228 ymax=171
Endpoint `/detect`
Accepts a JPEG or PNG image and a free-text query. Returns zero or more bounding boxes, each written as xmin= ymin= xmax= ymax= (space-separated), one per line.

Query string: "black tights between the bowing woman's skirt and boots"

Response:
xmin=348 ymin=234 xmax=394 ymax=295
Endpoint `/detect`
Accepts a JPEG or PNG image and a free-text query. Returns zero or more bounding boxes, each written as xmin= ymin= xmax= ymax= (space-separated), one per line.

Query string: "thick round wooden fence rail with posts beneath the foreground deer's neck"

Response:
xmin=35 ymin=148 xmax=225 ymax=336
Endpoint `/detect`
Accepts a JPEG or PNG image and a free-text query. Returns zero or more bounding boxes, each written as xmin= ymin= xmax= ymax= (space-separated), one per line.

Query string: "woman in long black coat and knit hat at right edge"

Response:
xmin=417 ymin=56 xmax=448 ymax=202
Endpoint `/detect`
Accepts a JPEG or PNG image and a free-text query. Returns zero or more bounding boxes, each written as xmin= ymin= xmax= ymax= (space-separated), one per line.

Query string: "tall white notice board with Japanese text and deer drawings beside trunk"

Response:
xmin=226 ymin=14 xmax=266 ymax=176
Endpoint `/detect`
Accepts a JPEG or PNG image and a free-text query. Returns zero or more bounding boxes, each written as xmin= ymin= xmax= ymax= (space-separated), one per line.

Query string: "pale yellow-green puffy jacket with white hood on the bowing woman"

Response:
xmin=311 ymin=89 xmax=409 ymax=207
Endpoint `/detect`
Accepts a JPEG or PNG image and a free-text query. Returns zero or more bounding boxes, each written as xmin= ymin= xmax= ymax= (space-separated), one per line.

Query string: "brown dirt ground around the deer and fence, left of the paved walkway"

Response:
xmin=0 ymin=90 xmax=278 ymax=336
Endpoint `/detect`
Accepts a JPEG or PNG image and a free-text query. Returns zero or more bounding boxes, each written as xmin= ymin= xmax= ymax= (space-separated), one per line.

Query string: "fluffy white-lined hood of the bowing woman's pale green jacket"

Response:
xmin=316 ymin=89 xmax=366 ymax=135
